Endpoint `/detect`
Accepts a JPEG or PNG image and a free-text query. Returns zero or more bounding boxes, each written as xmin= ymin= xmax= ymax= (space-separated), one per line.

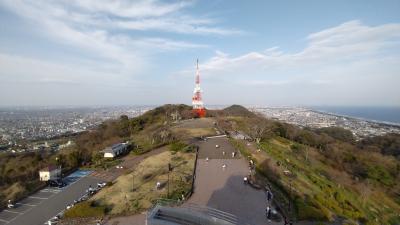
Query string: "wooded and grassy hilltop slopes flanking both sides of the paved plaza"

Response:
xmin=0 ymin=104 xmax=400 ymax=224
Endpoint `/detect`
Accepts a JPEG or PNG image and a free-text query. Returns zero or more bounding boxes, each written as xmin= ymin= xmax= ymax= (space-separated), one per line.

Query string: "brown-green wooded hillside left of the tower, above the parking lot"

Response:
xmin=0 ymin=104 xmax=193 ymax=208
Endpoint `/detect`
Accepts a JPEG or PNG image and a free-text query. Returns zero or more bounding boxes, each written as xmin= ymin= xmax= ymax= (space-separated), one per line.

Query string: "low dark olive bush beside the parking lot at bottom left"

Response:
xmin=64 ymin=201 xmax=106 ymax=218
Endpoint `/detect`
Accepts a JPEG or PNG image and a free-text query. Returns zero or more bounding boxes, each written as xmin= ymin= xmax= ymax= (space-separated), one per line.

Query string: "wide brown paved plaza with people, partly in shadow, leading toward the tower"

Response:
xmin=188 ymin=137 xmax=281 ymax=225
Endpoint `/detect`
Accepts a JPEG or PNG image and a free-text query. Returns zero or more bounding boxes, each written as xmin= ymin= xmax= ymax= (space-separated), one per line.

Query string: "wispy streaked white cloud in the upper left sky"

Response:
xmin=0 ymin=0 xmax=234 ymax=77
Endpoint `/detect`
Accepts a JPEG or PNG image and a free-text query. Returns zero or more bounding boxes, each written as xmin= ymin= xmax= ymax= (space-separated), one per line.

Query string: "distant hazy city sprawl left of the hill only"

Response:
xmin=0 ymin=106 xmax=153 ymax=153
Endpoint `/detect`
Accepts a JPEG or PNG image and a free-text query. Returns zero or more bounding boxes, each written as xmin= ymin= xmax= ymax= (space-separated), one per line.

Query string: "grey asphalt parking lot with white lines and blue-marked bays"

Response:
xmin=0 ymin=170 xmax=102 ymax=225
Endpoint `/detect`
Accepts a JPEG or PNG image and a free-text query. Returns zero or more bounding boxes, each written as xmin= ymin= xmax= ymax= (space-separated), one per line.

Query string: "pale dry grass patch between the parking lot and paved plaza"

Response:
xmin=93 ymin=151 xmax=195 ymax=215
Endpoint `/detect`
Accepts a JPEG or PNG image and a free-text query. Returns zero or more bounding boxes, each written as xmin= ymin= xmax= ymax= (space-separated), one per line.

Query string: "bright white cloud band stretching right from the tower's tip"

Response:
xmin=191 ymin=21 xmax=400 ymax=74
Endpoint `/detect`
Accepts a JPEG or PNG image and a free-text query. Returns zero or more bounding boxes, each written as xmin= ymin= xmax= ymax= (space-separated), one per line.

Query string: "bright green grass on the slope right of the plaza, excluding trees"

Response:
xmin=255 ymin=138 xmax=396 ymax=224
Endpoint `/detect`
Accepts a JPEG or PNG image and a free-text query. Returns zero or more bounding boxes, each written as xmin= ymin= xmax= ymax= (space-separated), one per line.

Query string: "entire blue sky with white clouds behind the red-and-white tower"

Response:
xmin=0 ymin=0 xmax=400 ymax=107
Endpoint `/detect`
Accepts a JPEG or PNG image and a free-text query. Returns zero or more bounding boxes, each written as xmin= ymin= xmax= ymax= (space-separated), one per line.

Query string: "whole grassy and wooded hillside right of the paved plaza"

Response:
xmin=219 ymin=111 xmax=400 ymax=224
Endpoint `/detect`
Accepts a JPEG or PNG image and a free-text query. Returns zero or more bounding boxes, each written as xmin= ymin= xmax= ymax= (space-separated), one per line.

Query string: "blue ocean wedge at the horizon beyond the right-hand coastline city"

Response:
xmin=310 ymin=106 xmax=400 ymax=124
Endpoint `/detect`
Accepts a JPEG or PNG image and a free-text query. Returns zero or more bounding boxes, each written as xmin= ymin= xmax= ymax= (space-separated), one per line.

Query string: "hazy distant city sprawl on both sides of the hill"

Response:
xmin=0 ymin=106 xmax=400 ymax=153
